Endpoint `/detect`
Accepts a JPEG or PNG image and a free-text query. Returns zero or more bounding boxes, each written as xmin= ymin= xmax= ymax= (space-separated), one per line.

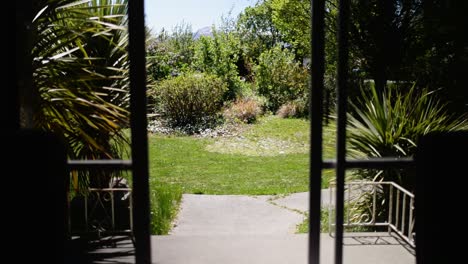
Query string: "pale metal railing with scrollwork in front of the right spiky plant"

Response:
xmin=328 ymin=181 xmax=416 ymax=247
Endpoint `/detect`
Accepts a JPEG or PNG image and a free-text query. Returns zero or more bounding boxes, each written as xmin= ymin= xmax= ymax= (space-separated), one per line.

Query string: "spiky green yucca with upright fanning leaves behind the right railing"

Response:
xmin=348 ymin=82 xmax=468 ymax=225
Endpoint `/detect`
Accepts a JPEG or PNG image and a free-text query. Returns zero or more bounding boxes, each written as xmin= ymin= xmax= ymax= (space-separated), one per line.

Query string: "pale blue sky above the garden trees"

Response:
xmin=145 ymin=0 xmax=256 ymax=33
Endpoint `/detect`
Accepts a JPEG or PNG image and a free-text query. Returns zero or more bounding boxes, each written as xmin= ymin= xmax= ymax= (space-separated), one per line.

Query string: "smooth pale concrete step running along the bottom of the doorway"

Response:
xmin=152 ymin=233 xmax=416 ymax=264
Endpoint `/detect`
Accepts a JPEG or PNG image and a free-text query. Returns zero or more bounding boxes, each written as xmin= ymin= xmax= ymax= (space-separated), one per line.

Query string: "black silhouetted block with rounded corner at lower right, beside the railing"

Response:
xmin=415 ymin=131 xmax=468 ymax=264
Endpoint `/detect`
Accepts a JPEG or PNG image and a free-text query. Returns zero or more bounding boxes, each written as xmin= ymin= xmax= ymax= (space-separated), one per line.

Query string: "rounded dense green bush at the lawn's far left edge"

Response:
xmin=156 ymin=73 xmax=226 ymax=133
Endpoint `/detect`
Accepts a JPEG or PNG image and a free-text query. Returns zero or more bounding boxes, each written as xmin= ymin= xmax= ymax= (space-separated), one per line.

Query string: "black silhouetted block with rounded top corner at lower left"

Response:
xmin=0 ymin=130 xmax=67 ymax=263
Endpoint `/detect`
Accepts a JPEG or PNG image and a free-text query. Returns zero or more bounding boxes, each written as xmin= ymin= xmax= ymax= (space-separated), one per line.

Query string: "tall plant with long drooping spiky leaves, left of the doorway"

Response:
xmin=32 ymin=0 xmax=129 ymax=190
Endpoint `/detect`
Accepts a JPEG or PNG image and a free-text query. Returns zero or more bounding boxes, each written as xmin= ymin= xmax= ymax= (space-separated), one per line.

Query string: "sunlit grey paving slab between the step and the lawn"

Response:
xmin=171 ymin=194 xmax=304 ymax=236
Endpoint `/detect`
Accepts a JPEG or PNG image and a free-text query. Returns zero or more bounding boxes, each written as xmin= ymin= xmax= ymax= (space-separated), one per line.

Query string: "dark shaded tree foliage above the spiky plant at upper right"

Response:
xmin=350 ymin=0 xmax=468 ymax=113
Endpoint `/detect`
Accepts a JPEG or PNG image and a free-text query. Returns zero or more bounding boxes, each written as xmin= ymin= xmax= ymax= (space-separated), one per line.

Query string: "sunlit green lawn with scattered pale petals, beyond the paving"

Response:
xmin=149 ymin=116 xmax=331 ymax=195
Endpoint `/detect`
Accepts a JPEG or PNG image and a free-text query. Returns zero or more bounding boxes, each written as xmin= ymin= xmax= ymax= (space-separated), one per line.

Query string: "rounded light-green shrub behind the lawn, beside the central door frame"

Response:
xmin=254 ymin=46 xmax=308 ymax=112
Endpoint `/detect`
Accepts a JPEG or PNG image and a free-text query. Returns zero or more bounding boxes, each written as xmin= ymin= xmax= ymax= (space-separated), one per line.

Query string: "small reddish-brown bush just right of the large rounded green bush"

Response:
xmin=223 ymin=97 xmax=262 ymax=124
